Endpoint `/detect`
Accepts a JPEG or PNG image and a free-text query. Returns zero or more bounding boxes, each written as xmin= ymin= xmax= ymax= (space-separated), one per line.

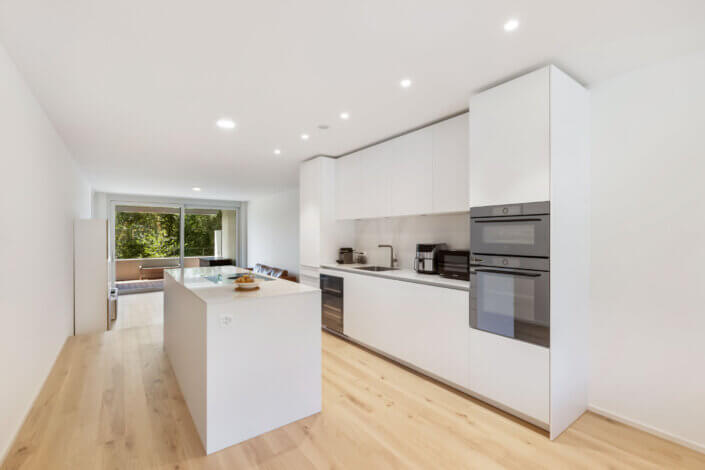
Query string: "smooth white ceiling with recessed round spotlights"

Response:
xmin=0 ymin=0 xmax=705 ymax=200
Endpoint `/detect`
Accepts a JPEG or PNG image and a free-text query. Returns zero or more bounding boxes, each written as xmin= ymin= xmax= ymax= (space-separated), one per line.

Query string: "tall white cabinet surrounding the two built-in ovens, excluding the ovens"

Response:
xmin=468 ymin=66 xmax=590 ymax=439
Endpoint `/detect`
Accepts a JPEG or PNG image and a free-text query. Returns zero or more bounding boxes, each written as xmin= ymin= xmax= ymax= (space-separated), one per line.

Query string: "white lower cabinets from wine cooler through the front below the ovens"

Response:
xmin=321 ymin=269 xmax=549 ymax=428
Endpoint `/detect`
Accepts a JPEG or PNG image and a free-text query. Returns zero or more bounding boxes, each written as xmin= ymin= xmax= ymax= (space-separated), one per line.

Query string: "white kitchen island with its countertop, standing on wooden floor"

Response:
xmin=164 ymin=266 xmax=321 ymax=454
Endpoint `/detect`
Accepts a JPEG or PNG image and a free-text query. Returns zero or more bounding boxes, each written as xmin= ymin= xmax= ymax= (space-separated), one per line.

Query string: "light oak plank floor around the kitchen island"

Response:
xmin=1 ymin=310 xmax=705 ymax=470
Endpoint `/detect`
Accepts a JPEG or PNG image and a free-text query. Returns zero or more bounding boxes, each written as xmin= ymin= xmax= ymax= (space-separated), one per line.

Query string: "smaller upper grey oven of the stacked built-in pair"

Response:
xmin=470 ymin=202 xmax=550 ymax=258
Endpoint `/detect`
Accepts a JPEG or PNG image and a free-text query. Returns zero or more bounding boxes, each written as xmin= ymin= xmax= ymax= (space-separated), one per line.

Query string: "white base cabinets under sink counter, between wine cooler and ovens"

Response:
xmin=334 ymin=270 xmax=469 ymax=387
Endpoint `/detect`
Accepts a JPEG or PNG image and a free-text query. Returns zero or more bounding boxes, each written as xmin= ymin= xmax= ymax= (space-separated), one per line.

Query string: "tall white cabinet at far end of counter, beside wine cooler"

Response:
xmin=299 ymin=157 xmax=352 ymax=287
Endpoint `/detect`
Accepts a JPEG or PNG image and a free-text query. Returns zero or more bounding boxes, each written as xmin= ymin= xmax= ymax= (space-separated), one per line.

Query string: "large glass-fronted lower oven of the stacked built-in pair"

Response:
xmin=470 ymin=267 xmax=551 ymax=347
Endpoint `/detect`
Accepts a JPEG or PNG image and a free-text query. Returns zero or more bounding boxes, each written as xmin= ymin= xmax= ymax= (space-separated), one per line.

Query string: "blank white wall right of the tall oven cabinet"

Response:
xmin=590 ymin=51 xmax=705 ymax=451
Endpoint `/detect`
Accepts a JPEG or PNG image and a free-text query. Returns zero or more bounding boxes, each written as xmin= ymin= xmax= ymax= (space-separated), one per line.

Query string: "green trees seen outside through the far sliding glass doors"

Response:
xmin=115 ymin=211 xmax=223 ymax=259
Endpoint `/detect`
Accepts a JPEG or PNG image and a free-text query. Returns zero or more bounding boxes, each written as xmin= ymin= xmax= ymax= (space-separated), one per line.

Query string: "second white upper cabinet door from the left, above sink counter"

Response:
xmin=359 ymin=143 xmax=394 ymax=218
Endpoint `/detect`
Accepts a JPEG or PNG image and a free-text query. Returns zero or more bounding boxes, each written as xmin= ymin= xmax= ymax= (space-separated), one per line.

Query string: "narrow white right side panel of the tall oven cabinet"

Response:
xmin=550 ymin=66 xmax=590 ymax=439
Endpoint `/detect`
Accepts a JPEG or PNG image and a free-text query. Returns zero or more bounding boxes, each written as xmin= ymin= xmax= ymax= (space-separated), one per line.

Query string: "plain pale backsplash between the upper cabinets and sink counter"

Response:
xmin=355 ymin=213 xmax=470 ymax=269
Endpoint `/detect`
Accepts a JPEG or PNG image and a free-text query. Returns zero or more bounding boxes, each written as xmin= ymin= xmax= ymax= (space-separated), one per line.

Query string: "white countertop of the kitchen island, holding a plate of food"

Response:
xmin=164 ymin=266 xmax=319 ymax=303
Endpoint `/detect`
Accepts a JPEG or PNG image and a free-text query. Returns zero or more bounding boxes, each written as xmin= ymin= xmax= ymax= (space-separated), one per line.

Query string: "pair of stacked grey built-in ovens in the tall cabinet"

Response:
xmin=470 ymin=202 xmax=551 ymax=347
